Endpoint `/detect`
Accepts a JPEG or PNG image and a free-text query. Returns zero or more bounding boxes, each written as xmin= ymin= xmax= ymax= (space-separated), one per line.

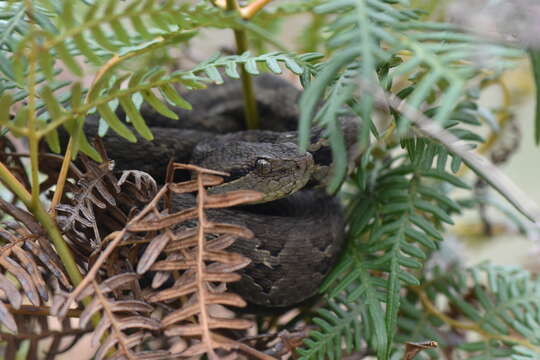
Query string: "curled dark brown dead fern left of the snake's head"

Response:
xmin=42 ymin=146 xmax=157 ymax=262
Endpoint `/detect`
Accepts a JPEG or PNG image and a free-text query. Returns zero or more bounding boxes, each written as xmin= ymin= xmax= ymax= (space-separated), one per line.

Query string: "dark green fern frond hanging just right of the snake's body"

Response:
xmin=314 ymin=139 xmax=468 ymax=359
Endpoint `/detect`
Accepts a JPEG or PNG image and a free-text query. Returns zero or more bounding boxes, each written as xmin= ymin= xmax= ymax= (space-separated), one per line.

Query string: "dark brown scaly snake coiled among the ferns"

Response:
xmin=68 ymin=74 xmax=355 ymax=308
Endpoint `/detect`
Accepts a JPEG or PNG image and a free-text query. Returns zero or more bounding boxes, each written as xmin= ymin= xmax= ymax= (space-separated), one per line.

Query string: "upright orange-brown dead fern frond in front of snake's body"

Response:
xmin=138 ymin=164 xmax=260 ymax=358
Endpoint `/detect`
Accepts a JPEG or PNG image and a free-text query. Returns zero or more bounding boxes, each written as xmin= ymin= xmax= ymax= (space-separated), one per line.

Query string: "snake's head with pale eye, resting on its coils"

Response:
xmin=192 ymin=140 xmax=314 ymax=202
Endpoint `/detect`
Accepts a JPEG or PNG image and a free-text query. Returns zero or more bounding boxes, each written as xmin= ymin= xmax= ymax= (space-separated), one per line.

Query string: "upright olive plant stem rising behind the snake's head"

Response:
xmin=227 ymin=0 xmax=259 ymax=130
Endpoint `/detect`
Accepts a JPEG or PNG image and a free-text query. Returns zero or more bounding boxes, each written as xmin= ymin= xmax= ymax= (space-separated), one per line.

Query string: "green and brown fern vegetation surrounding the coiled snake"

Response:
xmin=0 ymin=0 xmax=540 ymax=360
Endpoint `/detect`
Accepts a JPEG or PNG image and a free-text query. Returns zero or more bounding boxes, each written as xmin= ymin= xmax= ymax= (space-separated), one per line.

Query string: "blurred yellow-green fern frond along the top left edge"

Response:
xmin=4 ymin=0 xmax=247 ymax=82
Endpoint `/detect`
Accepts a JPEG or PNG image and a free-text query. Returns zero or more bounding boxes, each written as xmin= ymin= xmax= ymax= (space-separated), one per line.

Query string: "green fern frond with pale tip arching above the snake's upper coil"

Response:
xmin=4 ymin=49 xmax=318 ymax=159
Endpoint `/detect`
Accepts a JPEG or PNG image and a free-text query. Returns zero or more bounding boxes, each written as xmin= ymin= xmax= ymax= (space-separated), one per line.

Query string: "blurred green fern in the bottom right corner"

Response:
xmin=401 ymin=264 xmax=540 ymax=360
